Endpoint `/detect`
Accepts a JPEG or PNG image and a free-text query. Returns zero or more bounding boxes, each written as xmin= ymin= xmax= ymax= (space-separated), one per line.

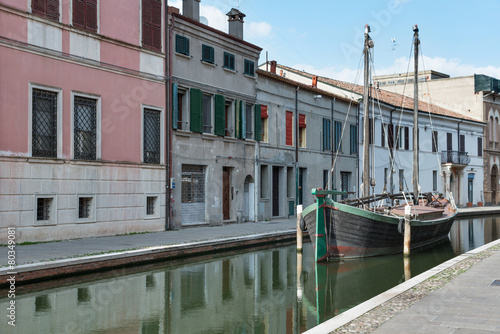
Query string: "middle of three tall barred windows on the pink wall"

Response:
xmin=73 ymin=96 xmax=97 ymax=160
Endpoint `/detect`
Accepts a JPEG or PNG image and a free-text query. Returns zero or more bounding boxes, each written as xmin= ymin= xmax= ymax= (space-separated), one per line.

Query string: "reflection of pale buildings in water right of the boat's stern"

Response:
xmin=450 ymin=217 xmax=500 ymax=254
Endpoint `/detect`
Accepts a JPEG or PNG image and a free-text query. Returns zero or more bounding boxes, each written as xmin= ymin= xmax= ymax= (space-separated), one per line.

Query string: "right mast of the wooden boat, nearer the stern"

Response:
xmin=413 ymin=24 xmax=420 ymax=205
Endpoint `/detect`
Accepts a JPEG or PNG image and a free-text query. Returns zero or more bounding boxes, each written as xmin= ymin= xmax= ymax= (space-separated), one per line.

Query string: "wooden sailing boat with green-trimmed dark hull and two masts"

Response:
xmin=302 ymin=26 xmax=457 ymax=262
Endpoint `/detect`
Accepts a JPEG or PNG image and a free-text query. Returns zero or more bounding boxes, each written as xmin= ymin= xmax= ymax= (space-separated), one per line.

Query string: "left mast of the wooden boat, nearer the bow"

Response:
xmin=363 ymin=24 xmax=373 ymax=197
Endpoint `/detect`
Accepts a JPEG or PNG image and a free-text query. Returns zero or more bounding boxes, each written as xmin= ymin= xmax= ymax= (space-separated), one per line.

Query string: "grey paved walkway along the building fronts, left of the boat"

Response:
xmin=0 ymin=219 xmax=297 ymax=270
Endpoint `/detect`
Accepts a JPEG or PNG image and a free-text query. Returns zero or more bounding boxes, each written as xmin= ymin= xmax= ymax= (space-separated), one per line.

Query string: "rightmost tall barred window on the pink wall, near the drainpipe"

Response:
xmin=143 ymin=108 xmax=160 ymax=164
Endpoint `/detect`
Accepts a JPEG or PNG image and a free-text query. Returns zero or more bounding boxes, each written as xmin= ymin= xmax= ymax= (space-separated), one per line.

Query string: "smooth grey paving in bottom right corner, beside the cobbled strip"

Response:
xmin=373 ymin=243 xmax=500 ymax=334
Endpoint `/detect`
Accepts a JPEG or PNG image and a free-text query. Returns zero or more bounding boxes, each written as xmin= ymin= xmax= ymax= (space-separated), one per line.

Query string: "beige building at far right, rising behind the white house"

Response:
xmin=374 ymin=71 xmax=500 ymax=204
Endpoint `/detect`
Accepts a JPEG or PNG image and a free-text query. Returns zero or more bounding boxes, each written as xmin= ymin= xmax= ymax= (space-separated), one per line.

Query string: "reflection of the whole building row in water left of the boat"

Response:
xmin=0 ymin=247 xmax=316 ymax=334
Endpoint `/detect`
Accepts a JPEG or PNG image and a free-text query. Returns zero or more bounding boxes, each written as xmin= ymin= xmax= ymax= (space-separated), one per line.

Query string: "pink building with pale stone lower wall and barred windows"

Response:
xmin=0 ymin=0 xmax=168 ymax=244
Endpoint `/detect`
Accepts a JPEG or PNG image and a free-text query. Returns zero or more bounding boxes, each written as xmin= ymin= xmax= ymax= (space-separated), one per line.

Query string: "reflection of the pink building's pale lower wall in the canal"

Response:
xmin=0 ymin=272 xmax=165 ymax=334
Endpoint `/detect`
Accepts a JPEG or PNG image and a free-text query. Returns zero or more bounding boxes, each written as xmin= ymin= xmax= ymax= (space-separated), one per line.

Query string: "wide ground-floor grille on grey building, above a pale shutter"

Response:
xmin=182 ymin=165 xmax=205 ymax=203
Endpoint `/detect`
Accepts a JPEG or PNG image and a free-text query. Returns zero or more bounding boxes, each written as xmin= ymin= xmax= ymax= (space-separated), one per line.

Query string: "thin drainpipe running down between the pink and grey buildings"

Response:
xmin=165 ymin=5 xmax=174 ymax=231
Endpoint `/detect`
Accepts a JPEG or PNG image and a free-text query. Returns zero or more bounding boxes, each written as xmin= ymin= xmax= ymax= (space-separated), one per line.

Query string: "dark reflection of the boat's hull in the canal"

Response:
xmin=303 ymin=239 xmax=456 ymax=324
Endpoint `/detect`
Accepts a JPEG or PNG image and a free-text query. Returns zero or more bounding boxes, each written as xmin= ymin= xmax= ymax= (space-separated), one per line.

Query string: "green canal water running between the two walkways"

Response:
xmin=0 ymin=216 xmax=500 ymax=334
